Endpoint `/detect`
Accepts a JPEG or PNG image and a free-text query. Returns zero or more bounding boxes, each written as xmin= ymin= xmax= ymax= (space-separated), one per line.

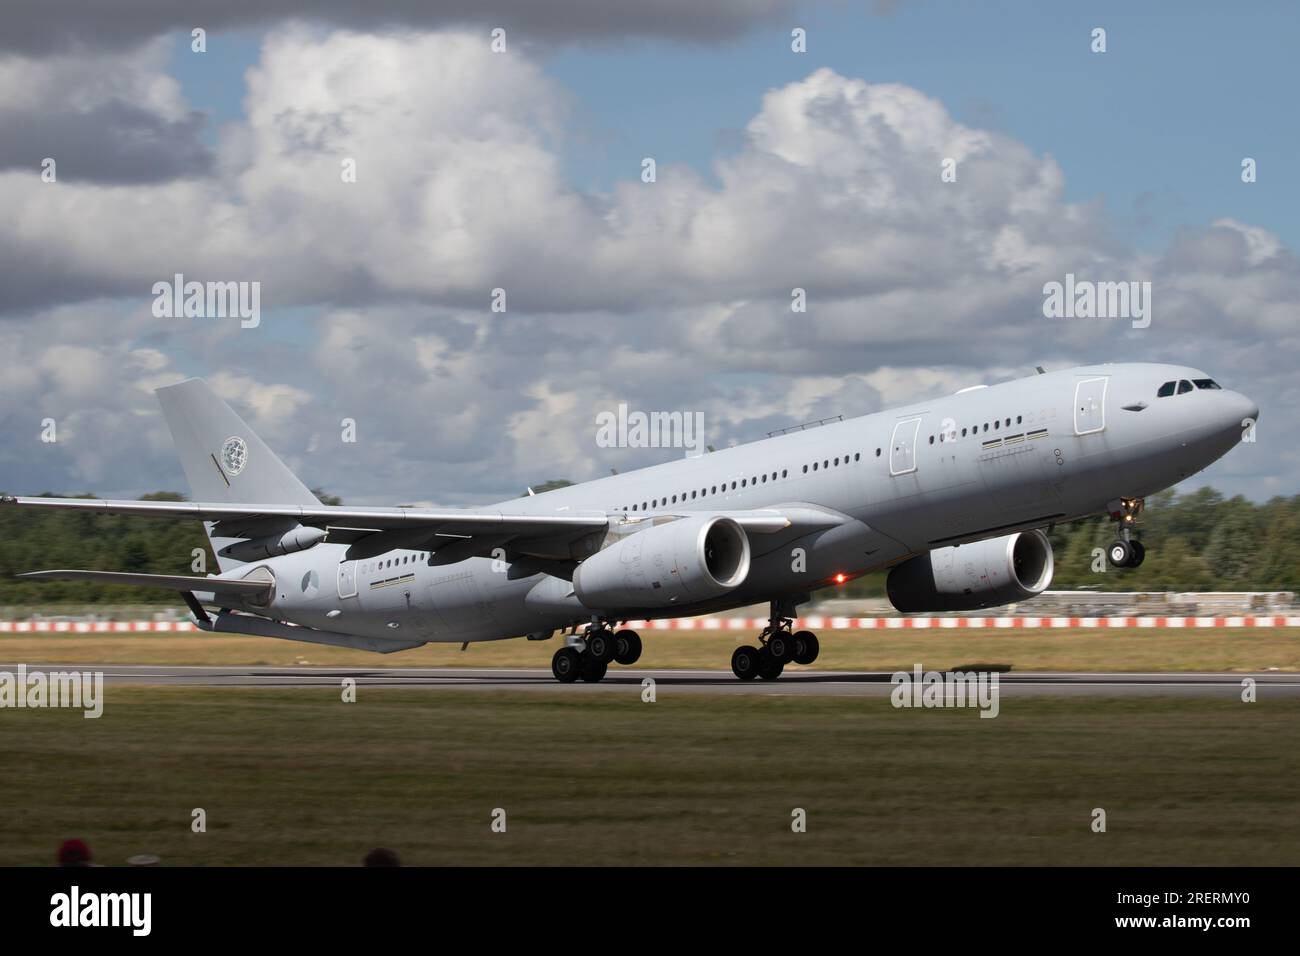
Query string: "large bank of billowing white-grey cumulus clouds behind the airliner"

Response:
xmin=0 ymin=26 xmax=1300 ymax=505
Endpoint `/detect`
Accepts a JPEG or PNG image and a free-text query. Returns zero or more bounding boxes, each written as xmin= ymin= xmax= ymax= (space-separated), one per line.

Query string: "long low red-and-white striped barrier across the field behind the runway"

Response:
xmin=0 ymin=614 xmax=1300 ymax=633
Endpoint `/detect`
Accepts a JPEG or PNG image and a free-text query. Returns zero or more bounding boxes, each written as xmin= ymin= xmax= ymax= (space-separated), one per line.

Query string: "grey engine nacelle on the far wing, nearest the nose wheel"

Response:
xmin=885 ymin=531 xmax=1054 ymax=614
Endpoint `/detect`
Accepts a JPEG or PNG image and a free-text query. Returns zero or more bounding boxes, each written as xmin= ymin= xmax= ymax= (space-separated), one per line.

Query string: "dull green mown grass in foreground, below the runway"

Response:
xmin=0 ymin=685 xmax=1300 ymax=865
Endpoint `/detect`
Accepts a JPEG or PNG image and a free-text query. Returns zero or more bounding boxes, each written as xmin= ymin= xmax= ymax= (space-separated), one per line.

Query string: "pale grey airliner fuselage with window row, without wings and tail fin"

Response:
xmin=250 ymin=364 xmax=1258 ymax=641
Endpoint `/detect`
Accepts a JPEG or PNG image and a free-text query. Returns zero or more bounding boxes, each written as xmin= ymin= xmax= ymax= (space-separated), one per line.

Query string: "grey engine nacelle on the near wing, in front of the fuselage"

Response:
xmin=573 ymin=515 xmax=749 ymax=610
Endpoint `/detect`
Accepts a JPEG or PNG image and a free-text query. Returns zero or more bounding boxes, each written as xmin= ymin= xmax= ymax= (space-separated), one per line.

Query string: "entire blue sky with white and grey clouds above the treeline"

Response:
xmin=0 ymin=0 xmax=1300 ymax=505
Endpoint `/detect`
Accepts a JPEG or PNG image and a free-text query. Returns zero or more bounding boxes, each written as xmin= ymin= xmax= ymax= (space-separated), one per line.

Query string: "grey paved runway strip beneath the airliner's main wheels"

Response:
xmin=0 ymin=663 xmax=1300 ymax=702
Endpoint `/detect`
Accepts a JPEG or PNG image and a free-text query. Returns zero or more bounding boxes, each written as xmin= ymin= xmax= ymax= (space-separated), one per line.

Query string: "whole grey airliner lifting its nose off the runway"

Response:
xmin=4 ymin=364 xmax=1258 ymax=682
